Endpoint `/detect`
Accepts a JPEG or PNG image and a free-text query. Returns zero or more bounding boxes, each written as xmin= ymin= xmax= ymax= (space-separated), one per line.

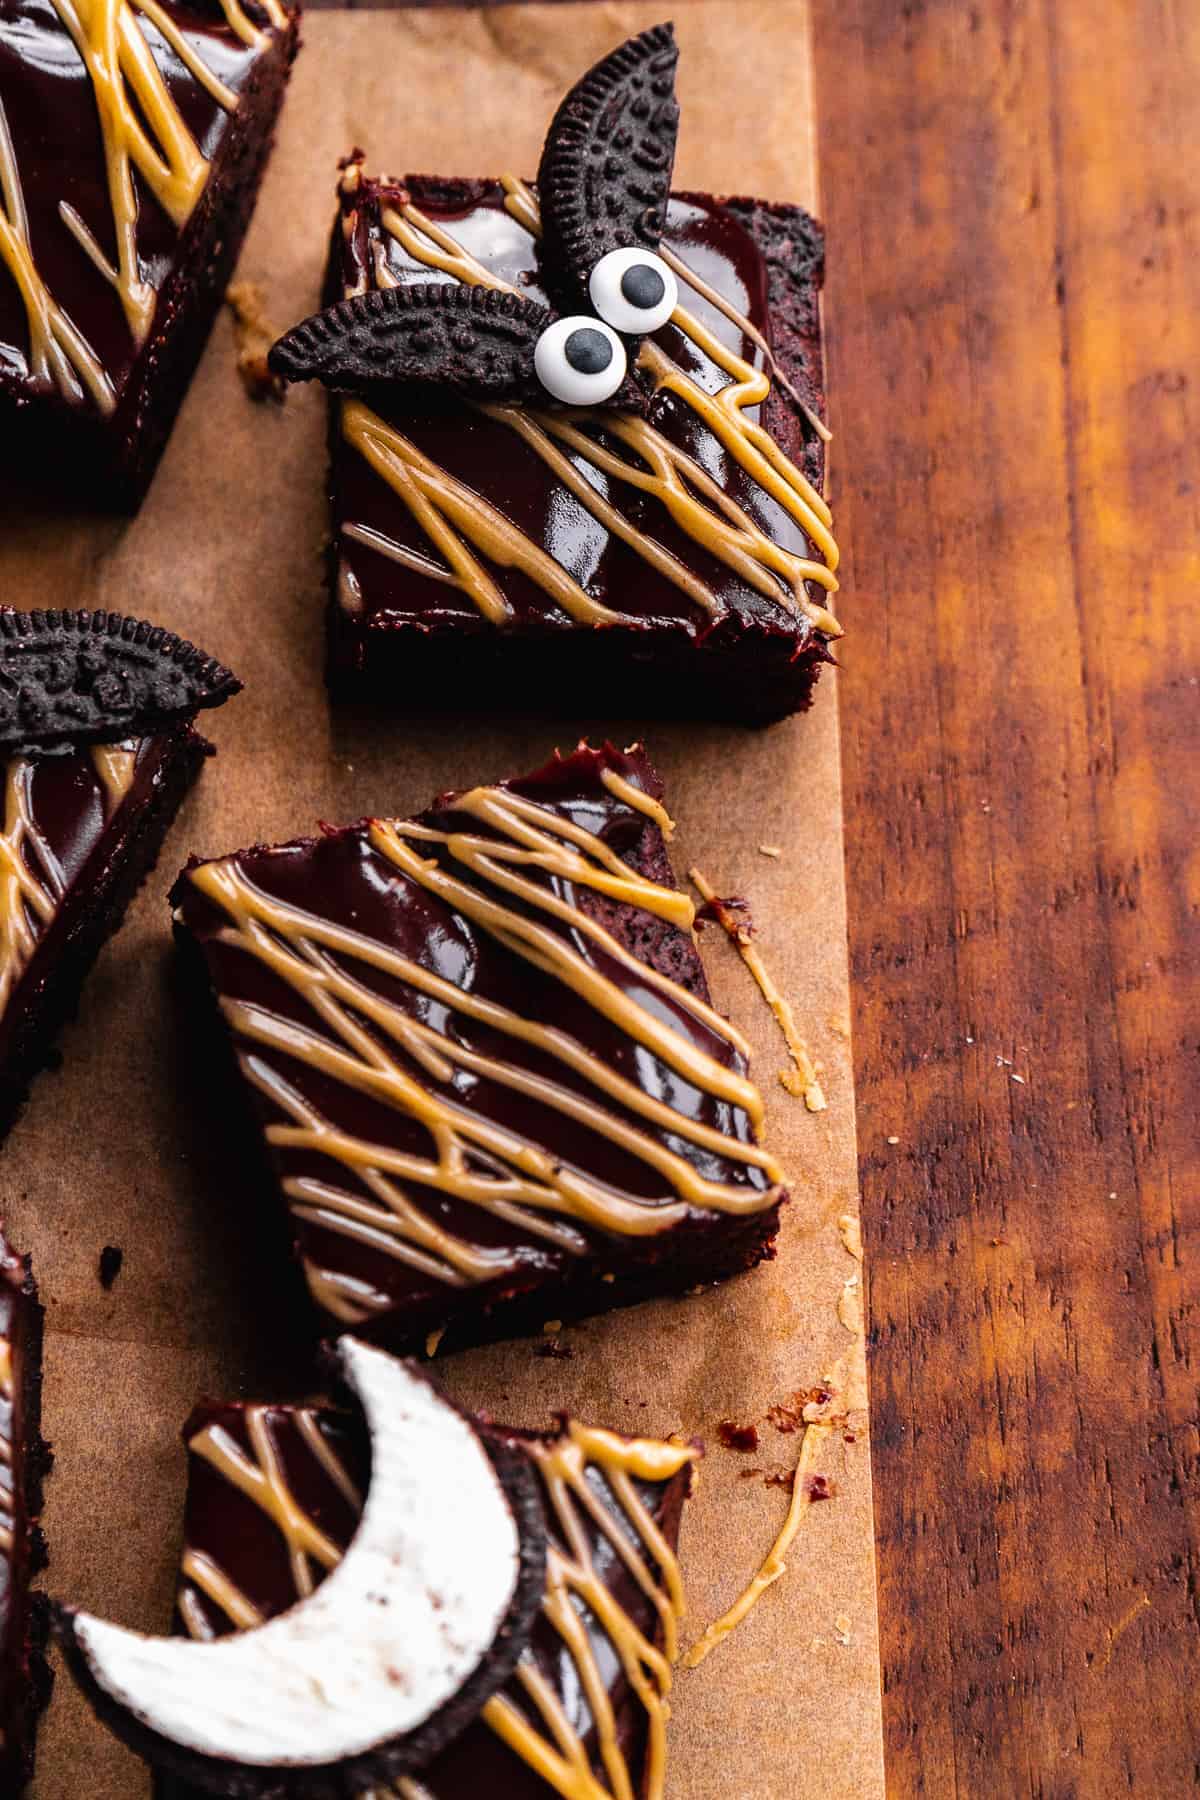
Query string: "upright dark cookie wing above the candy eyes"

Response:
xmin=538 ymin=23 xmax=678 ymax=306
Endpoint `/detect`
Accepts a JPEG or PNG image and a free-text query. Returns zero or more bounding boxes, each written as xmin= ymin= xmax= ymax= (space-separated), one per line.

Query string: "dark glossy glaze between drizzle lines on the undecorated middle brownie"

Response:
xmin=173 ymin=745 xmax=777 ymax=1345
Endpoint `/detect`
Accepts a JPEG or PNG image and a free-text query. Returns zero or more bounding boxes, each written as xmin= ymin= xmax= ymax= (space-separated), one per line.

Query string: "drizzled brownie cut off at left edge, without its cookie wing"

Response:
xmin=0 ymin=727 xmax=210 ymax=1136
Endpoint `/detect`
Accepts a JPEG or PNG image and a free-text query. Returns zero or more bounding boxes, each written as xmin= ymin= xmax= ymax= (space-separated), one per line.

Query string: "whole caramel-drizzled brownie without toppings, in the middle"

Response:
xmin=171 ymin=745 xmax=784 ymax=1348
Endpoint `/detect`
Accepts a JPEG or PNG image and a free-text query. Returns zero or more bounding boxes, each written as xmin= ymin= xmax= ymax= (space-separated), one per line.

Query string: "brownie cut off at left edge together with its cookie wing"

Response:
xmin=0 ymin=610 xmax=239 ymax=1136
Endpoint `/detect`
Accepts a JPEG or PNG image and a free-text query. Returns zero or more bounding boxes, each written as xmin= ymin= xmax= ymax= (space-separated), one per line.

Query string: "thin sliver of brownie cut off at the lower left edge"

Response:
xmin=0 ymin=1235 xmax=47 ymax=1795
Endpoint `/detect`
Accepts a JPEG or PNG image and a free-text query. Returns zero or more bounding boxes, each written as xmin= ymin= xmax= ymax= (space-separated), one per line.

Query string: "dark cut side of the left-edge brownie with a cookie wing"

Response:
xmin=0 ymin=727 xmax=212 ymax=1136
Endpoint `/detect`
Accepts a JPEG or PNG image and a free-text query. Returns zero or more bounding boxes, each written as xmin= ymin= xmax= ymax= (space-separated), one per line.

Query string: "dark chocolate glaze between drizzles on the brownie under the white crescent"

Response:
xmin=157 ymin=1404 xmax=689 ymax=1800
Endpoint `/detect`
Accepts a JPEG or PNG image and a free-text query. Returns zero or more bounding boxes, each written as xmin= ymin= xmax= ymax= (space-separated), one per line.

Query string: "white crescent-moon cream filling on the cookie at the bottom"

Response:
xmin=76 ymin=1337 xmax=520 ymax=1768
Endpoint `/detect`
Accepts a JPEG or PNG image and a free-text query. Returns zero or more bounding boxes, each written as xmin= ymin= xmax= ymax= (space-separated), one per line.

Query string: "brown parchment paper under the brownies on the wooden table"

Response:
xmin=0 ymin=0 xmax=882 ymax=1800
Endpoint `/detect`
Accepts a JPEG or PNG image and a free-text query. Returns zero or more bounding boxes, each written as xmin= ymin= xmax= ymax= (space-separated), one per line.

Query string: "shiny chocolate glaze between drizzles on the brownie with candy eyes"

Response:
xmin=329 ymin=176 xmax=822 ymax=644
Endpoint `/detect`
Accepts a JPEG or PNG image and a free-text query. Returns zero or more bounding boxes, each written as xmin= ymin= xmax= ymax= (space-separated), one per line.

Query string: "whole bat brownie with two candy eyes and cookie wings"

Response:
xmin=272 ymin=25 xmax=840 ymax=724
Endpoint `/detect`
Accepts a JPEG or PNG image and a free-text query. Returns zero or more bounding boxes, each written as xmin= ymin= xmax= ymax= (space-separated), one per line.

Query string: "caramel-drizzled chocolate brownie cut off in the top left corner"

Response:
xmin=0 ymin=0 xmax=299 ymax=508
